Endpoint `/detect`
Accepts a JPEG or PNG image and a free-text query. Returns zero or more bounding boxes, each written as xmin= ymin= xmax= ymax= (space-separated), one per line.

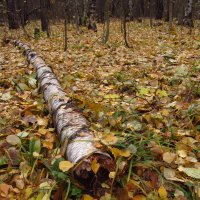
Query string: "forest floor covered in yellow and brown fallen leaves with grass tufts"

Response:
xmin=0 ymin=21 xmax=200 ymax=200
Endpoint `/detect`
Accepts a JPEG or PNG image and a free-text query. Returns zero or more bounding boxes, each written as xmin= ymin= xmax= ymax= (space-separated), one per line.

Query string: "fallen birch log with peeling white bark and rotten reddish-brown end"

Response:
xmin=14 ymin=41 xmax=114 ymax=192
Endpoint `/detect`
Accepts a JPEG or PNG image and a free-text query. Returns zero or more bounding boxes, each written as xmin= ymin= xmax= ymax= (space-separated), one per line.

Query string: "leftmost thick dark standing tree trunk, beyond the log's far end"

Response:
xmin=6 ymin=0 xmax=19 ymax=29
